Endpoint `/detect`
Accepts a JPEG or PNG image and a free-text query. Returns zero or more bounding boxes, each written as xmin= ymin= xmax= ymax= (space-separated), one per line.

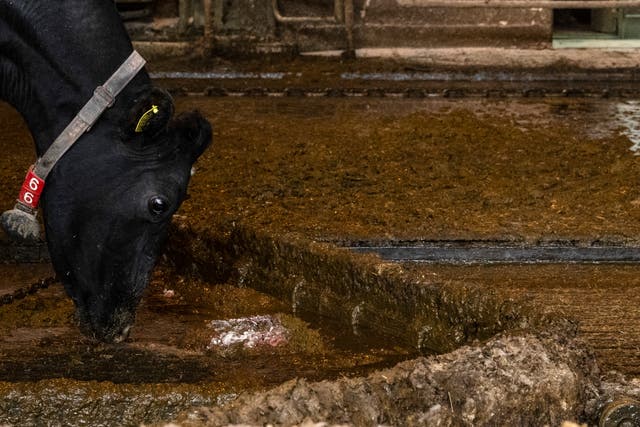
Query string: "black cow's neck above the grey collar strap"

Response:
xmin=0 ymin=0 xmax=149 ymax=155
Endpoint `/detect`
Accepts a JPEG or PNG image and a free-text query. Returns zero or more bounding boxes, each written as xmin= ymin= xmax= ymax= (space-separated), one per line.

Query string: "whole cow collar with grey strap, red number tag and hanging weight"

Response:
xmin=0 ymin=50 xmax=145 ymax=240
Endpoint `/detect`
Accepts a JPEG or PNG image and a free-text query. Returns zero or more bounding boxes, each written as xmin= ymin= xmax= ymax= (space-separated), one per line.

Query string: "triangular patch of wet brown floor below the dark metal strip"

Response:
xmin=416 ymin=264 xmax=640 ymax=377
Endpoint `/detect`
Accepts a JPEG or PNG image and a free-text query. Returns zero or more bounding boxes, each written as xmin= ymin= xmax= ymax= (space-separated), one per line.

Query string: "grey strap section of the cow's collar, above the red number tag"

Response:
xmin=33 ymin=50 xmax=145 ymax=180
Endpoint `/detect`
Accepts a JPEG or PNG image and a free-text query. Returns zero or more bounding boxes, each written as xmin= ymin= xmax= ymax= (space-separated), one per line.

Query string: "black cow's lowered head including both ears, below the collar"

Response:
xmin=43 ymin=91 xmax=211 ymax=342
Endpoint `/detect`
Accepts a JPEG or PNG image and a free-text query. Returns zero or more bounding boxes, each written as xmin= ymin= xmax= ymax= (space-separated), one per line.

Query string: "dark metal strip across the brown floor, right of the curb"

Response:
xmin=345 ymin=241 xmax=640 ymax=264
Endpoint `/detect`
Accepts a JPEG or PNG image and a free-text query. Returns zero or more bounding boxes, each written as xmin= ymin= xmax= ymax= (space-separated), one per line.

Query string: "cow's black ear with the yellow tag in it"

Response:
xmin=123 ymin=88 xmax=173 ymax=144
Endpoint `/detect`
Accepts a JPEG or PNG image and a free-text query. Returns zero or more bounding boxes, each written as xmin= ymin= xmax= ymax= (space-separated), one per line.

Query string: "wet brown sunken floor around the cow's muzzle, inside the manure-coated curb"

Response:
xmin=0 ymin=266 xmax=409 ymax=391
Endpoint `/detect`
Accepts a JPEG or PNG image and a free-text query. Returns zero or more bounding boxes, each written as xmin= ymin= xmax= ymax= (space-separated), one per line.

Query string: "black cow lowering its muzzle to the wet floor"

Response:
xmin=0 ymin=0 xmax=211 ymax=342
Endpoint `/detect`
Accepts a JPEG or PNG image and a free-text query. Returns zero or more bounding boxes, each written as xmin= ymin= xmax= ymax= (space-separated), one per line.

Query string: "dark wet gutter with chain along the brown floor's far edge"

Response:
xmin=151 ymin=69 xmax=640 ymax=99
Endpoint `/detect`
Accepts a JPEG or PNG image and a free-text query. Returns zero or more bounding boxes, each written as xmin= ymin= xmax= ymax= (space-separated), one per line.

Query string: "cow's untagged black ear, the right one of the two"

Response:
xmin=171 ymin=111 xmax=212 ymax=163
